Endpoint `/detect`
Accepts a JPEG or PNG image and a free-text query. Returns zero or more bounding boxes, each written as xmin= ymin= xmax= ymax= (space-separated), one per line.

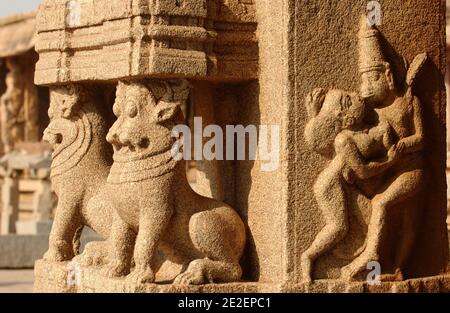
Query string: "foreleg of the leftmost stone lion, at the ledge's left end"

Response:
xmin=44 ymin=197 xmax=82 ymax=262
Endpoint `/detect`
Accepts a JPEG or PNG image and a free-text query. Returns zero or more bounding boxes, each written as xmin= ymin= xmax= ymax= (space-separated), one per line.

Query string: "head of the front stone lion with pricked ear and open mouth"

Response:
xmin=106 ymin=81 xmax=189 ymax=161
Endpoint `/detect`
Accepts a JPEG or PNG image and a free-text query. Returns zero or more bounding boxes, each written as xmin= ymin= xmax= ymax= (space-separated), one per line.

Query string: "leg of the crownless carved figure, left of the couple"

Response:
xmin=301 ymin=157 xmax=348 ymax=282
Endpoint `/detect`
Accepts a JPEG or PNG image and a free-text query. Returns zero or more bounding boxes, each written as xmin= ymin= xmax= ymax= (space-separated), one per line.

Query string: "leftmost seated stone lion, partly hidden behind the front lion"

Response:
xmin=44 ymin=85 xmax=112 ymax=261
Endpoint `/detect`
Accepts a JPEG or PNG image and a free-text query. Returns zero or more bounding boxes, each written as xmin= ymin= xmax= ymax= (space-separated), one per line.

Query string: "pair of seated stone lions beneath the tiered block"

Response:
xmin=44 ymin=82 xmax=245 ymax=284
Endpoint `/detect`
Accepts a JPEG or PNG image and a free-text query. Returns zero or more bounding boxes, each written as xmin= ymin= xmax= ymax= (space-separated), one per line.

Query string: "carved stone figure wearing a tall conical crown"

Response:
xmin=341 ymin=18 xmax=427 ymax=279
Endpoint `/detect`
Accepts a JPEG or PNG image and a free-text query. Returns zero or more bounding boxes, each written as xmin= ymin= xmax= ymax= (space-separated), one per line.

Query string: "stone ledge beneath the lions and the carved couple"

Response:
xmin=34 ymin=260 xmax=450 ymax=293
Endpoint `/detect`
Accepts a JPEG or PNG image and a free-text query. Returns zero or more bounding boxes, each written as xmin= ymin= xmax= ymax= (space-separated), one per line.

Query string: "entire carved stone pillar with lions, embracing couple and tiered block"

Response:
xmin=35 ymin=0 xmax=450 ymax=292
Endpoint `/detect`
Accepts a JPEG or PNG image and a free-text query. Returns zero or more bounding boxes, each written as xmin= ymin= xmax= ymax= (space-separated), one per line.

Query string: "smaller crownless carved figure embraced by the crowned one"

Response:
xmin=301 ymin=89 xmax=395 ymax=282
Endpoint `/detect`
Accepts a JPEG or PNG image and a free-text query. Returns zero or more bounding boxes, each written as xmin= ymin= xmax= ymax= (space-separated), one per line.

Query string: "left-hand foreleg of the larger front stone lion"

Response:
xmin=102 ymin=210 xmax=136 ymax=277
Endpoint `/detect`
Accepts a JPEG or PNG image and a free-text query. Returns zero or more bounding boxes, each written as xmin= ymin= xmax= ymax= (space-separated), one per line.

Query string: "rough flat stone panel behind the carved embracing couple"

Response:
xmin=285 ymin=1 xmax=448 ymax=280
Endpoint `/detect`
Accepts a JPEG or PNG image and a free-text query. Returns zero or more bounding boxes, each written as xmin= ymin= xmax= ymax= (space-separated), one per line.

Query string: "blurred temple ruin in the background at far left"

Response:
xmin=0 ymin=12 xmax=56 ymax=268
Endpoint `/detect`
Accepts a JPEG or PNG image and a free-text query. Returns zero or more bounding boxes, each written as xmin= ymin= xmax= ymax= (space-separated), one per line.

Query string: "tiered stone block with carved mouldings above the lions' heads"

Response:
xmin=35 ymin=0 xmax=258 ymax=85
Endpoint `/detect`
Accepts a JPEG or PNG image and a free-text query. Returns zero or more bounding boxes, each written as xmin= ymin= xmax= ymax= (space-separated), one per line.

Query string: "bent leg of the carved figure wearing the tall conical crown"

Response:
xmin=341 ymin=170 xmax=423 ymax=279
